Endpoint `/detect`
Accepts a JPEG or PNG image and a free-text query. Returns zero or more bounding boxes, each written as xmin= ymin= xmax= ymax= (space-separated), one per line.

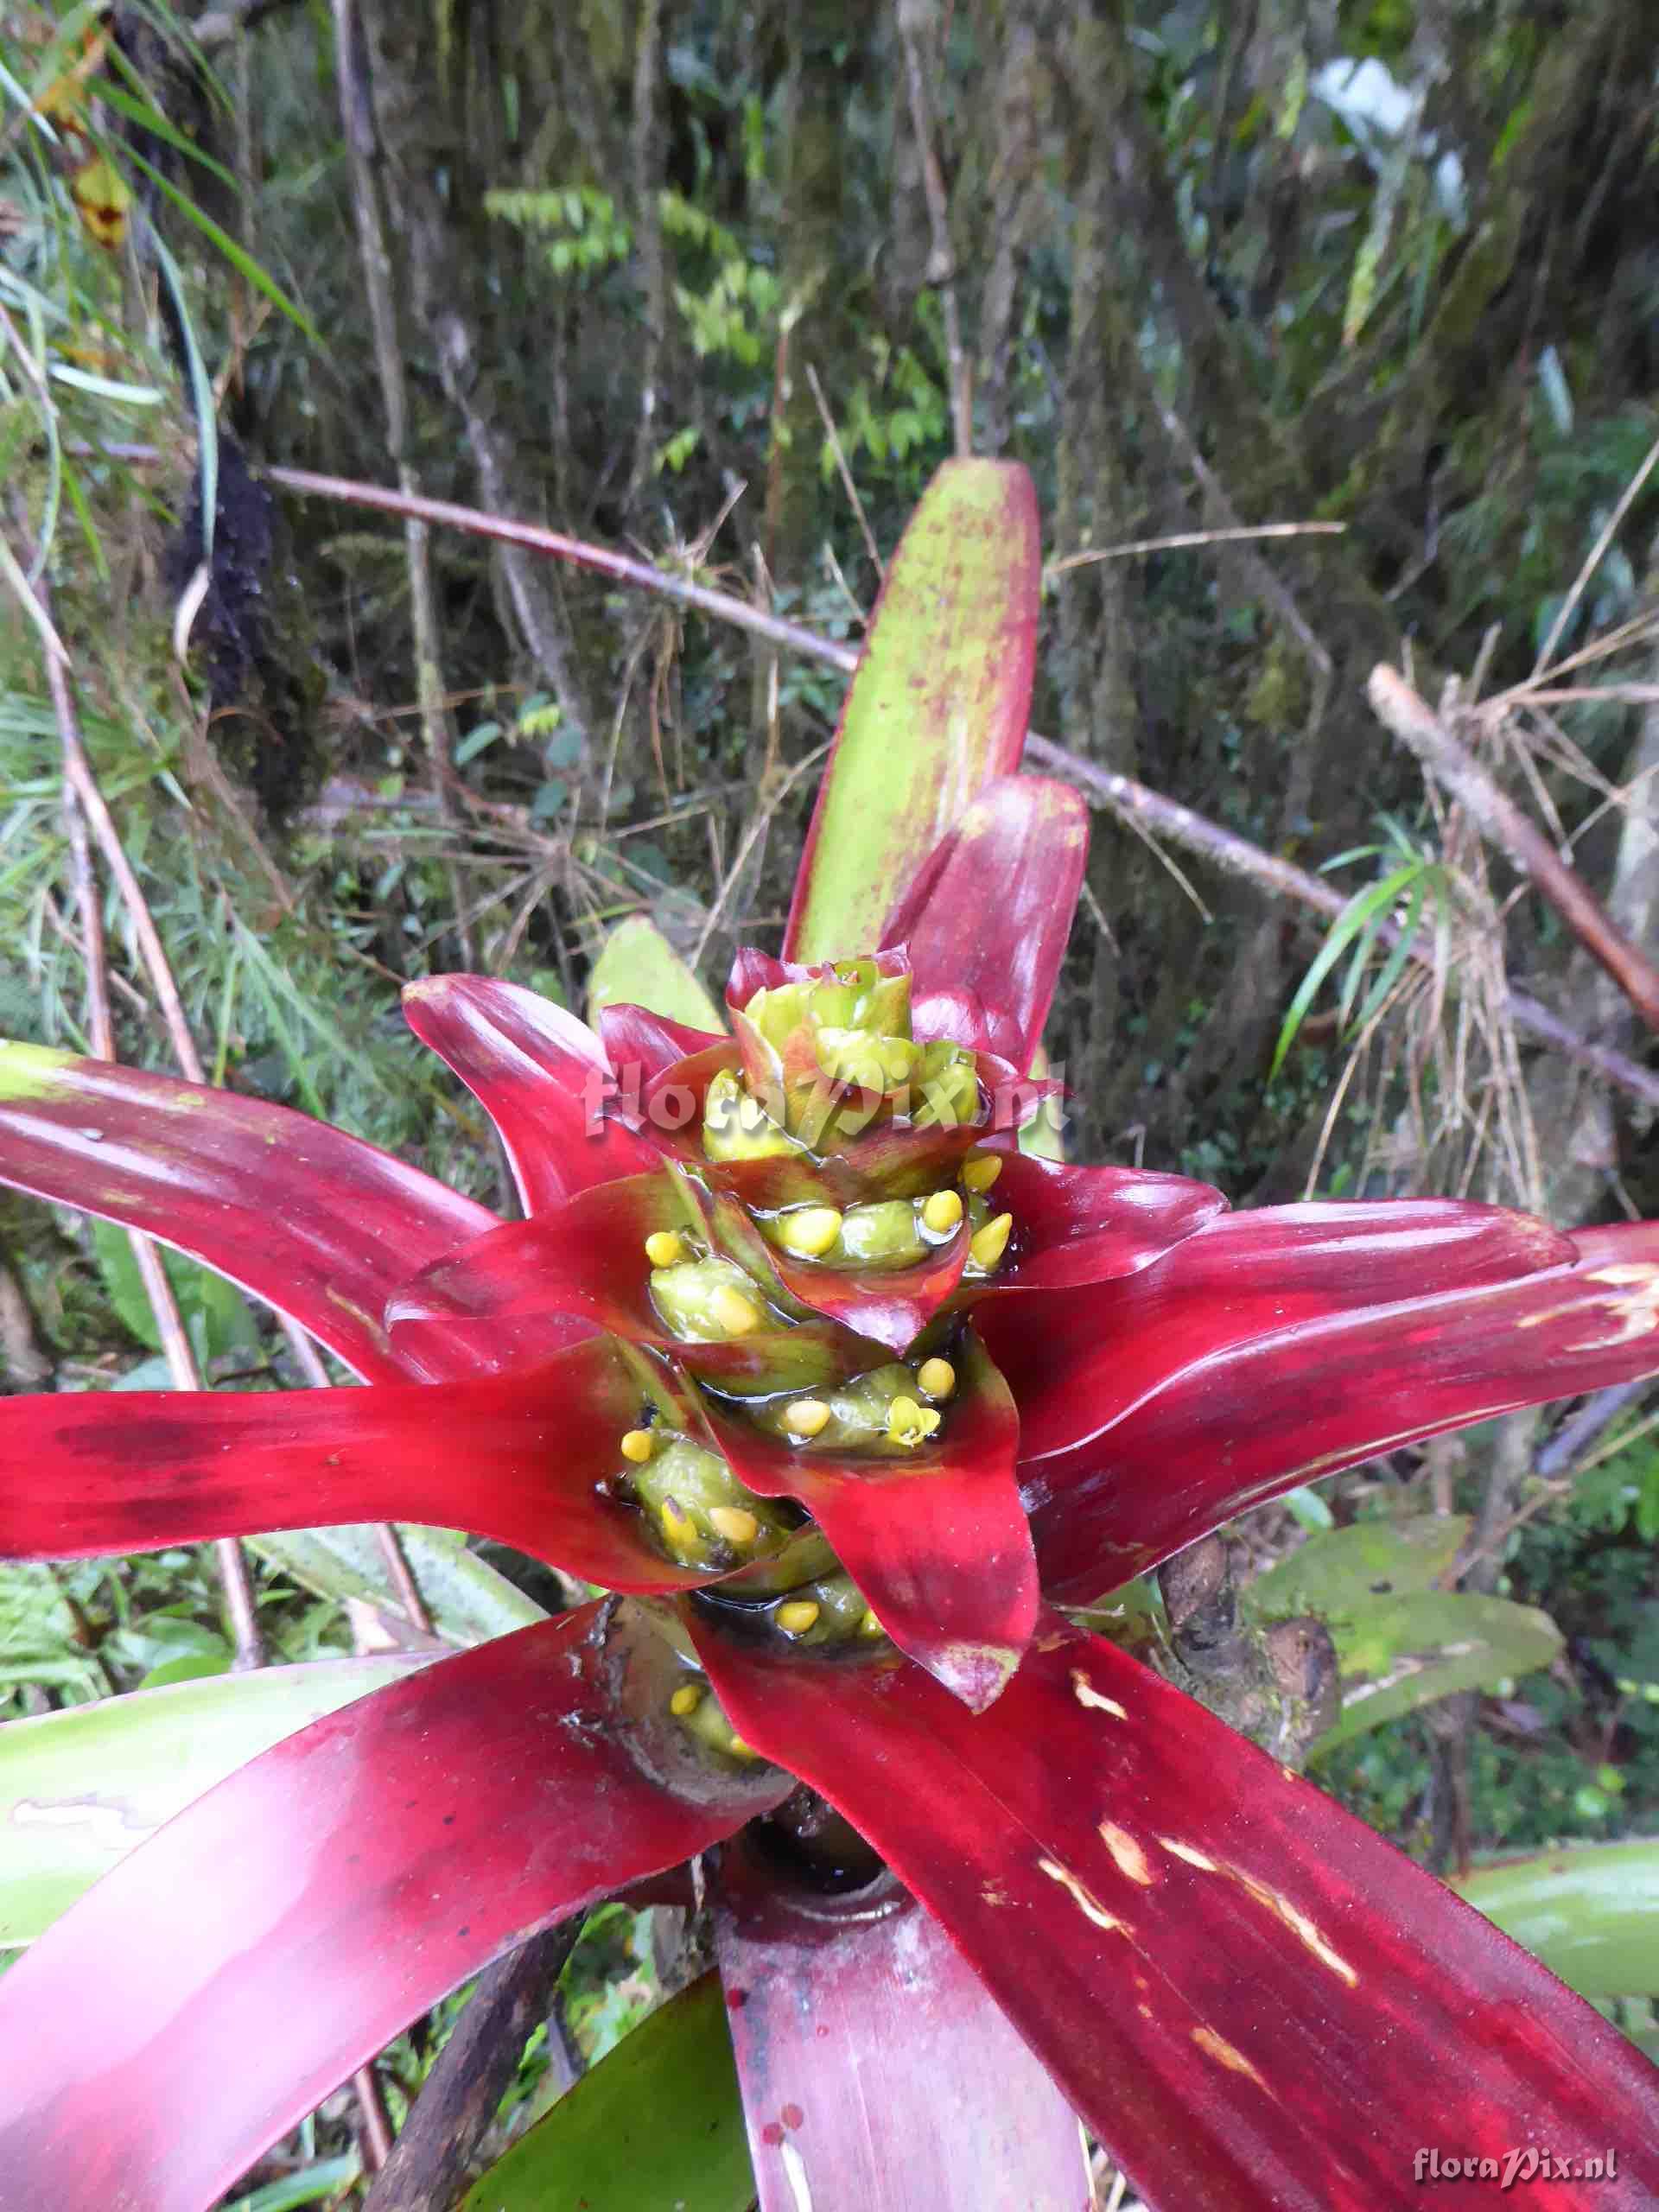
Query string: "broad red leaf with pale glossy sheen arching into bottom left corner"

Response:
xmin=0 ymin=1606 xmax=787 ymax=2212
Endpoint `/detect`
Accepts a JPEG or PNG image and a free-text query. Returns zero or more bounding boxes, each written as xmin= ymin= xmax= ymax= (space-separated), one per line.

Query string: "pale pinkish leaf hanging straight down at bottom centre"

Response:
xmin=715 ymin=1842 xmax=1092 ymax=2212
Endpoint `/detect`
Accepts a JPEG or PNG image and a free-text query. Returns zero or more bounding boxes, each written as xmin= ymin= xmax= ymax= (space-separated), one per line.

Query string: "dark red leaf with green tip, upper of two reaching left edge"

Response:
xmin=0 ymin=1044 xmax=493 ymax=1376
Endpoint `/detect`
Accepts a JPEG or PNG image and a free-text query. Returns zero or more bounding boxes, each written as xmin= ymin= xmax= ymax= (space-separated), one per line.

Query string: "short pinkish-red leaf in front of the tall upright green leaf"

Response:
xmin=880 ymin=777 xmax=1089 ymax=1068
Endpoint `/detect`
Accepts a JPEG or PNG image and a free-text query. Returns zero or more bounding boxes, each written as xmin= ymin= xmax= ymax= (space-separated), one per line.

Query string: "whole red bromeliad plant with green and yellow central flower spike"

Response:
xmin=0 ymin=462 xmax=1659 ymax=2212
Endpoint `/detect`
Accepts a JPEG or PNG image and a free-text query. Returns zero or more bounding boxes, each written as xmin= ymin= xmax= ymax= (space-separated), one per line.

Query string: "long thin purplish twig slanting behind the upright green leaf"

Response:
xmin=265 ymin=469 xmax=1659 ymax=1106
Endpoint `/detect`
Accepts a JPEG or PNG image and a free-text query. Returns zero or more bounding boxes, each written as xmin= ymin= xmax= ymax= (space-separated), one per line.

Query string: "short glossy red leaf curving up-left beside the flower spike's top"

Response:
xmin=403 ymin=976 xmax=657 ymax=1214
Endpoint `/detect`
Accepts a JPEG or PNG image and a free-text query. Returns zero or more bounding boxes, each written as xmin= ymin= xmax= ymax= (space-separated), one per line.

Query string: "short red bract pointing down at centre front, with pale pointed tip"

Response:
xmin=708 ymin=1338 xmax=1038 ymax=1712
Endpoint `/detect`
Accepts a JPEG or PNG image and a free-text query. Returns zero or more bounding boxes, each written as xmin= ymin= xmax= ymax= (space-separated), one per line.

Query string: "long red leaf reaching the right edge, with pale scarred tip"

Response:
xmin=1013 ymin=1214 xmax=1659 ymax=1601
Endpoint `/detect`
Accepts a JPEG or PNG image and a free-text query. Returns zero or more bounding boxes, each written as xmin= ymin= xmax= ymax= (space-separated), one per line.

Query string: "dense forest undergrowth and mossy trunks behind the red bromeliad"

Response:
xmin=0 ymin=0 xmax=1659 ymax=2203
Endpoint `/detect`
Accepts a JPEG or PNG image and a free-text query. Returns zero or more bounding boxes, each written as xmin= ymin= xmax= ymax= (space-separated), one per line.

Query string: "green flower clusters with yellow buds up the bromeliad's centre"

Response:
xmin=641 ymin=960 xmax=1013 ymax=1758
